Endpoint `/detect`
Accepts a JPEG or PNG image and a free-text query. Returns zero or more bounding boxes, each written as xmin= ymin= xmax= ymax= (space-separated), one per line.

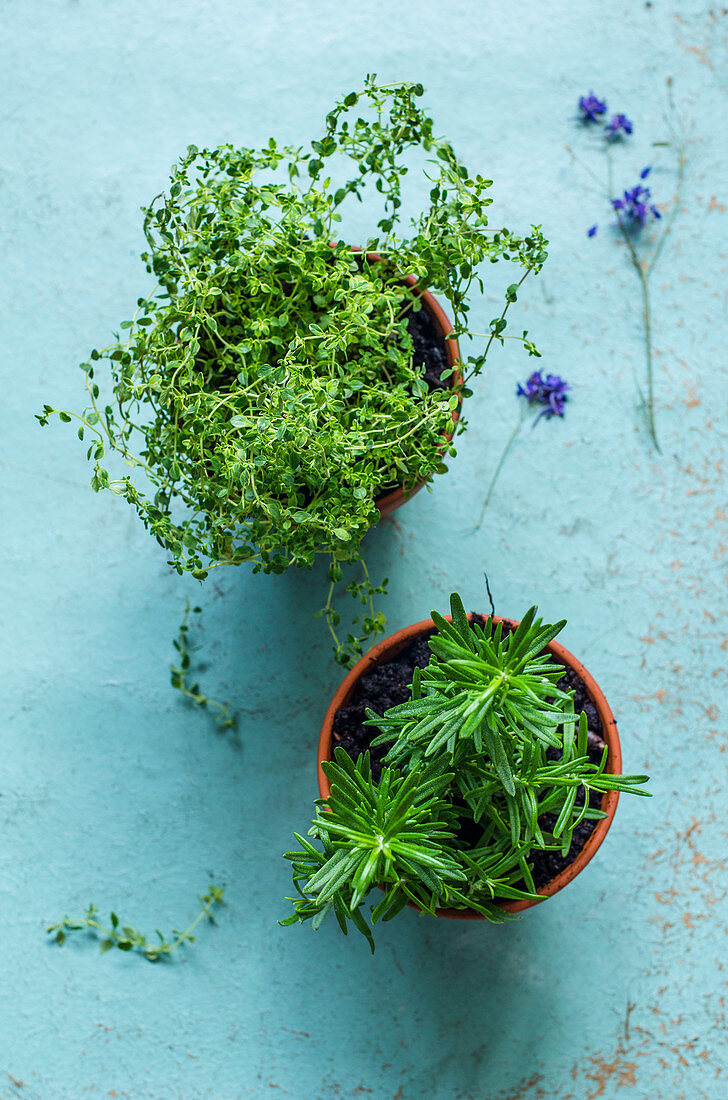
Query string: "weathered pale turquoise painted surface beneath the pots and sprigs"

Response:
xmin=0 ymin=0 xmax=728 ymax=1100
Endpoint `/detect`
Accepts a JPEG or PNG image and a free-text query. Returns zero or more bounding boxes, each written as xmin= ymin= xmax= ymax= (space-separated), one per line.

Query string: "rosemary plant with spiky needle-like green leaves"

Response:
xmin=280 ymin=594 xmax=648 ymax=949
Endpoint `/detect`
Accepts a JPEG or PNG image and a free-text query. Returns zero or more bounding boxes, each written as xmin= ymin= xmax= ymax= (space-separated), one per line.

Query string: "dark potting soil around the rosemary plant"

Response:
xmin=333 ymin=615 xmax=605 ymax=888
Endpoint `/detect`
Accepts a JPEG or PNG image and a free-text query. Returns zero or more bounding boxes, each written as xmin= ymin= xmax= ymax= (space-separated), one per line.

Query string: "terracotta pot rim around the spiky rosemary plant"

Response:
xmin=317 ymin=614 xmax=621 ymax=921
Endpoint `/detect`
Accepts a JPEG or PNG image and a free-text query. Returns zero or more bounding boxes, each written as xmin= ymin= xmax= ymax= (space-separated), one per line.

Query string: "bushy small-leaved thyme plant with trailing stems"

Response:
xmin=38 ymin=76 xmax=547 ymax=663
